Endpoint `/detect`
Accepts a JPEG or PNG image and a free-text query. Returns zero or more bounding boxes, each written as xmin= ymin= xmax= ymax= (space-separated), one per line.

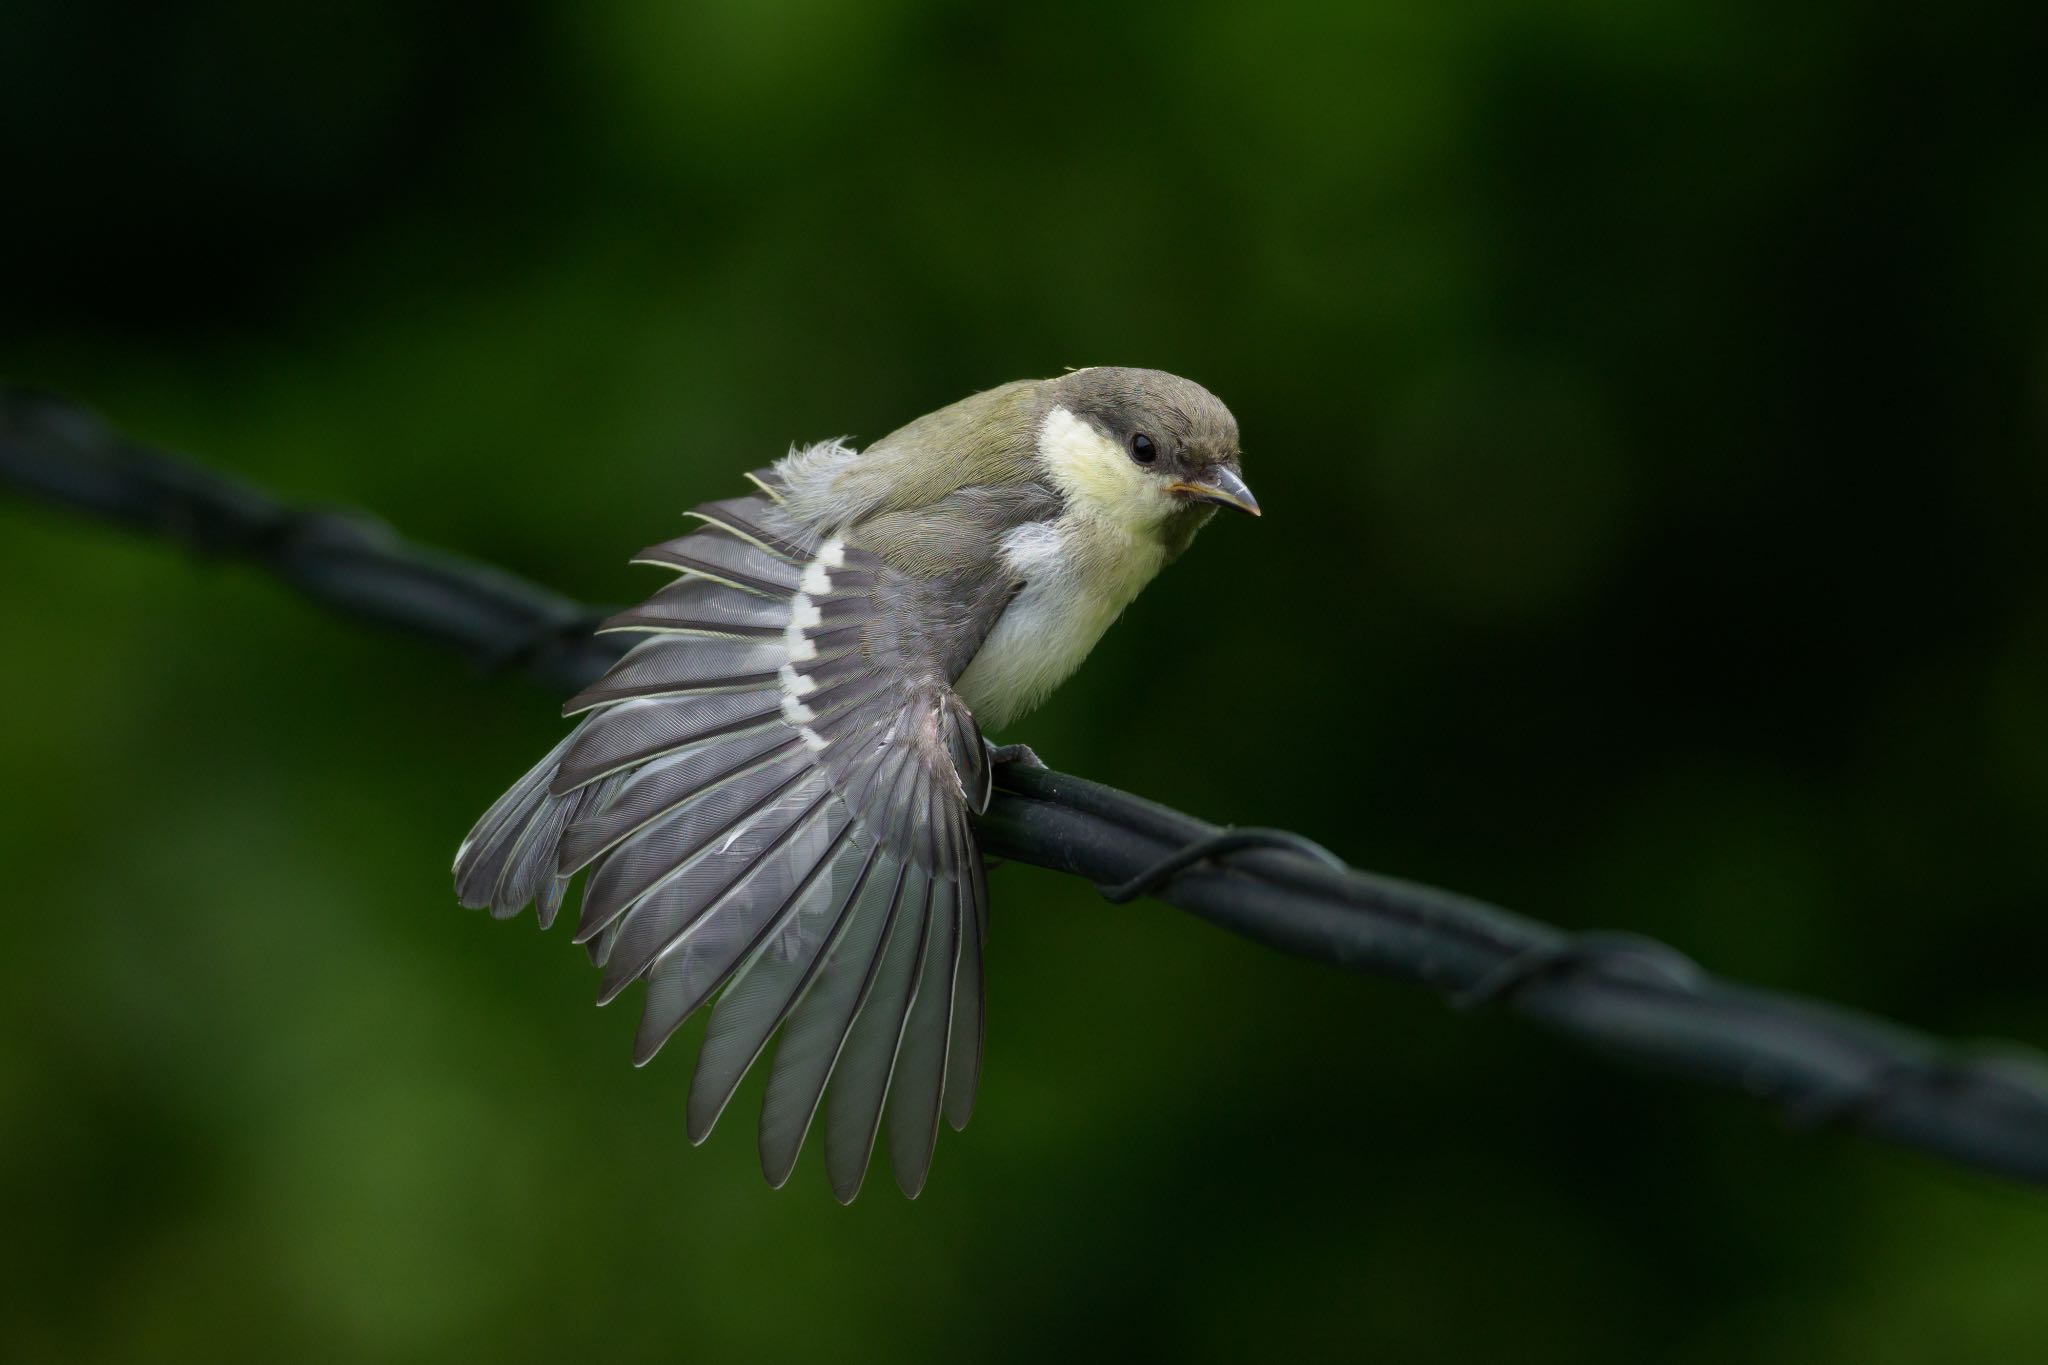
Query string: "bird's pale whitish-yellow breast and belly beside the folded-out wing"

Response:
xmin=954 ymin=516 xmax=1165 ymax=731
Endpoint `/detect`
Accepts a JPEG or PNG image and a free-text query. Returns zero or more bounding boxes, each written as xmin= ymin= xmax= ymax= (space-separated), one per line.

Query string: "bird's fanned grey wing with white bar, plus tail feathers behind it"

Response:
xmin=455 ymin=483 xmax=1006 ymax=1201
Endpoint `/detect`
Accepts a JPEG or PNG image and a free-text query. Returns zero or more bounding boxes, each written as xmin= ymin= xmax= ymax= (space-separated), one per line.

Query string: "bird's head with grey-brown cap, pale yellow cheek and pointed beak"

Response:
xmin=1036 ymin=366 xmax=1260 ymax=553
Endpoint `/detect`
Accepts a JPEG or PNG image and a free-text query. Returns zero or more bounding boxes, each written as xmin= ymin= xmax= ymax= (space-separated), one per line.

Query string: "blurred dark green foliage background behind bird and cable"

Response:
xmin=0 ymin=0 xmax=2048 ymax=1365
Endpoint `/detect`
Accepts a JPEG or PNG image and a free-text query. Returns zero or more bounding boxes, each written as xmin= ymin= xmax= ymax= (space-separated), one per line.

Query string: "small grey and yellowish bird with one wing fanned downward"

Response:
xmin=455 ymin=366 xmax=1260 ymax=1201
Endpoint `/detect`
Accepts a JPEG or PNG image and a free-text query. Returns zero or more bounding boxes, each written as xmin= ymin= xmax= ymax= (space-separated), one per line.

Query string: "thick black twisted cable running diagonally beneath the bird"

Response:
xmin=12 ymin=387 xmax=2048 ymax=1185
